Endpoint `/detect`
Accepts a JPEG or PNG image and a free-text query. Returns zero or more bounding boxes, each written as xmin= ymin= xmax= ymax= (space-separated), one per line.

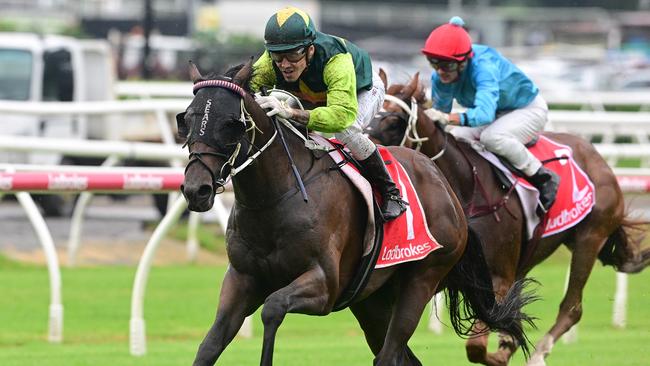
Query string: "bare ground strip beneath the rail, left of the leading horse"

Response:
xmin=0 ymin=196 xmax=227 ymax=266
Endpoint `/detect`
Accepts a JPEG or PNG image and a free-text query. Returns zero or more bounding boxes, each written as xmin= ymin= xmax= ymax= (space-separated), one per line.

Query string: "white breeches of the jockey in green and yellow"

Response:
xmin=334 ymin=72 xmax=386 ymax=160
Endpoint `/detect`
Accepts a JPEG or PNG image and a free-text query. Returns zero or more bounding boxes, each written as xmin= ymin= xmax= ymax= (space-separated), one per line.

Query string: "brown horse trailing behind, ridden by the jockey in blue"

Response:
xmin=368 ymin=73 xmax=650 ymax=366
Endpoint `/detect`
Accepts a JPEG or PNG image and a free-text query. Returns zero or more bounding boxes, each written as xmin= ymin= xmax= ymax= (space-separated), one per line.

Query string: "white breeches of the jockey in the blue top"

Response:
xmin=450 ymin=95 xmax=548 ymax=176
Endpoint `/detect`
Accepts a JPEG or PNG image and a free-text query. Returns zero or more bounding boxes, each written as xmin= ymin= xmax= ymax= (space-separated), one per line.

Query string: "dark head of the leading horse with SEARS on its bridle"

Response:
xmin=176 ymin=62 xmax=267 ymax=212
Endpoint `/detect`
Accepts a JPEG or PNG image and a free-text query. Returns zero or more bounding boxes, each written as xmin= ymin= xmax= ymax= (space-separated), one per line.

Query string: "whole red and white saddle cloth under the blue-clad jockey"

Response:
xmin=472 ymin=135 xmax=596 ymax=239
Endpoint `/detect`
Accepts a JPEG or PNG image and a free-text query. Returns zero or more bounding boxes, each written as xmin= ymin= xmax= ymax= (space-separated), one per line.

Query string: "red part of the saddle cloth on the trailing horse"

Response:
xmin=518 ymin=136 xmax=596 ymax=237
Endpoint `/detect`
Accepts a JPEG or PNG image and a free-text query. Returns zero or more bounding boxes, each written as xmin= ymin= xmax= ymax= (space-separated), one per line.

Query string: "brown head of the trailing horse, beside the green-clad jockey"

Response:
xmin=366 ymin=73 xmax=424 ymax=146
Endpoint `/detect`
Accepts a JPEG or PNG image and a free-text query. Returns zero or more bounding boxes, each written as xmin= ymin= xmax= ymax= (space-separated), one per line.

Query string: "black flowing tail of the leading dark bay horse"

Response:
xmin=446 ymin=229 xmax=538 ymax=358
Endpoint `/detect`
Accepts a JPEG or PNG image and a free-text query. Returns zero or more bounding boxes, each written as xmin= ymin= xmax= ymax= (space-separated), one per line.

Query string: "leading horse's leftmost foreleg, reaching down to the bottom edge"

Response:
xmin=193 ymin=267 xmax=262 ymax=366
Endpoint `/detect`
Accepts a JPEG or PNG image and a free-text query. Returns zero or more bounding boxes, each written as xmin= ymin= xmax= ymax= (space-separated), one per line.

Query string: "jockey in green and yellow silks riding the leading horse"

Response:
xmin=250 ymin=7 xmax=406 ymax=220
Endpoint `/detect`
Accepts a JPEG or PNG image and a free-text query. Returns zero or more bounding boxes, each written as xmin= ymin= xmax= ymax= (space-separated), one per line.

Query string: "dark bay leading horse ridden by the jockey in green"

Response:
xmin=177 ymin=62 xmax=534 ymax=366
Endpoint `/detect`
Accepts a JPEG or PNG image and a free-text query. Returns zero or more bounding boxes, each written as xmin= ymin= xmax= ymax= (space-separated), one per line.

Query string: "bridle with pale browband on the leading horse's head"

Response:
xmin=185 ymin=80 xmax=278 ymax=193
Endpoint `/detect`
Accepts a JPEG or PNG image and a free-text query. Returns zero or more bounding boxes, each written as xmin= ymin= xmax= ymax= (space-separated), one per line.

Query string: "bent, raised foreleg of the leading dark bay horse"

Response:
xmin=260 ymin=267 xmax=330 ymax=366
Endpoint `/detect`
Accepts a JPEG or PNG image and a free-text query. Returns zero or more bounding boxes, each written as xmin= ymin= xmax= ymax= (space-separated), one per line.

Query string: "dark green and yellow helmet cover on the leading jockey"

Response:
xmin=264 ymin=6 xmax=316 ymax=52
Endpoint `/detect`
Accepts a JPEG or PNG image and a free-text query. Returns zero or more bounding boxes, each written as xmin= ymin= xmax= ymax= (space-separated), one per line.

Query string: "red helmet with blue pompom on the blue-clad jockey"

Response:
xmin=422 ymin=17 xmax=473 ymax=61
